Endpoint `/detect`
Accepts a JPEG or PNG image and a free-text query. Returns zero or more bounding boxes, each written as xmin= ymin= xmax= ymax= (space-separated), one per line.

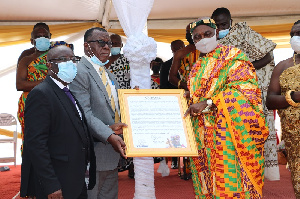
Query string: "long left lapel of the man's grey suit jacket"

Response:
xmin=81 ymin=57 xmax=113 ymax=111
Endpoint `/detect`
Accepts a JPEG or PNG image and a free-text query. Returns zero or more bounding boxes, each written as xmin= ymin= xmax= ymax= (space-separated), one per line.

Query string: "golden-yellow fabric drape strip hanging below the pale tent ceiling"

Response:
xmin=0 ymin=22 xmax=293 ymax=48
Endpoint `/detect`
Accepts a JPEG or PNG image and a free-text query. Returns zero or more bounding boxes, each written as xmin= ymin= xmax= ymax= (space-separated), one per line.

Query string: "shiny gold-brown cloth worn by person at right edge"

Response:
xmin=278 ymin=64 xmax=300 ymax=198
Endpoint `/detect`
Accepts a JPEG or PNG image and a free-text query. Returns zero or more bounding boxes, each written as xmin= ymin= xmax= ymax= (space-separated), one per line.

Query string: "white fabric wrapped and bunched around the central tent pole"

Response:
xmin=113 ymin=0 xmax=156 ymax=199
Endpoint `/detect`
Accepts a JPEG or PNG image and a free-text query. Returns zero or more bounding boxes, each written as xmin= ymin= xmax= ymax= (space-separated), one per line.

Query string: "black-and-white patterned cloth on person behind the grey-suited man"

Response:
xmin=108 ymin=54 xmax=130 ymax=89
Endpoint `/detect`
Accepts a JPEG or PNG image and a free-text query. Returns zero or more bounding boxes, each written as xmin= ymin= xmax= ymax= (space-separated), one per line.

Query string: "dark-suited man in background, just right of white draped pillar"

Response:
xmin=160 ymin=40 xmax=184 ymax=89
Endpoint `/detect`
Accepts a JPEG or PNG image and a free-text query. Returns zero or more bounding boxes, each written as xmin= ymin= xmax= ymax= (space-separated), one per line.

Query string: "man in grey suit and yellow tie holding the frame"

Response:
xmin=70 ymin=28 xmax=127 ymax=199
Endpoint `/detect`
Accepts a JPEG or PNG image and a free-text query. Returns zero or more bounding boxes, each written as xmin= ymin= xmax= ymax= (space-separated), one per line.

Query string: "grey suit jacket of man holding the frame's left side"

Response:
xmin=70 ymin=57 xmax=120 ymax=171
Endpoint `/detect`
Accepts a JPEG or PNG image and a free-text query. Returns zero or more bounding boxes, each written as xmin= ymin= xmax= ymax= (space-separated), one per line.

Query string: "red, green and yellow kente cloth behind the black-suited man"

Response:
xmin=18 ymin=52 xmax=48 ymax=152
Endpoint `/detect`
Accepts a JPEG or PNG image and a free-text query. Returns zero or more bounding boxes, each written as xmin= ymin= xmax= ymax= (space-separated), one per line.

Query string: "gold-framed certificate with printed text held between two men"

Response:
xmin=118 ymin=89 xmax=198 ymax=157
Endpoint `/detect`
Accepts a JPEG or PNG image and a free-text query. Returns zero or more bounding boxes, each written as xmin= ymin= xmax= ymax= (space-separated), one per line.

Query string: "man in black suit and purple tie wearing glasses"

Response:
xmin=20 ymin=46 xmax=95 ymax=199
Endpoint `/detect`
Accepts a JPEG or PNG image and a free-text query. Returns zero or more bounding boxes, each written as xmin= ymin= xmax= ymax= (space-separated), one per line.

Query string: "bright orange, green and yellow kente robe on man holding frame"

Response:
xmin=188 ymin=45 xmax=269 ymax=199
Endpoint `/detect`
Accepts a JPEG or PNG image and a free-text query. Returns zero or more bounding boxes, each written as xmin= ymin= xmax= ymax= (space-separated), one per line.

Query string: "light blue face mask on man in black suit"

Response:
xmin=51 ymin=60 xmax=77 ymax=84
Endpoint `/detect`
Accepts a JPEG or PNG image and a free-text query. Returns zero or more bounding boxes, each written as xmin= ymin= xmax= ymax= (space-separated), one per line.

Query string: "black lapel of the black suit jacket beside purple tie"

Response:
xmin=45 ymin=76 xmax=87 ymax=143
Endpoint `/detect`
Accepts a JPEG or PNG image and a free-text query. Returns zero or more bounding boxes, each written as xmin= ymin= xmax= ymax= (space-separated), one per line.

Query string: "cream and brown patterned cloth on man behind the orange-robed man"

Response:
xmin=219 ymin=22 xmax=280 ymax=180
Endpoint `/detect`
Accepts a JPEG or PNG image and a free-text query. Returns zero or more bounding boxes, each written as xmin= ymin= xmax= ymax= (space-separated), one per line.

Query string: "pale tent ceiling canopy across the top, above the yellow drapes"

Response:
xmin=0 ymin=0 xmax=300 ymax=29
